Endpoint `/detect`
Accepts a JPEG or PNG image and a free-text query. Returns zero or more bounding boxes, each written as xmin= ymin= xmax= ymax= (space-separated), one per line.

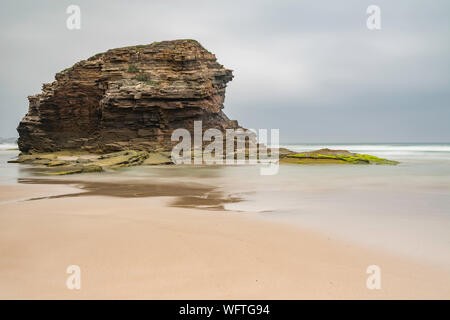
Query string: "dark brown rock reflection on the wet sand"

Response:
xmin=18 ymin=178 xmax=242 ymax=210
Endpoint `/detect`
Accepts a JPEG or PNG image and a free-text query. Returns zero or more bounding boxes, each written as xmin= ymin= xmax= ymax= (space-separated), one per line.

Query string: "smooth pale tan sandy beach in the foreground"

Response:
xmin=0 ymin=180 xmax=450 ymax=299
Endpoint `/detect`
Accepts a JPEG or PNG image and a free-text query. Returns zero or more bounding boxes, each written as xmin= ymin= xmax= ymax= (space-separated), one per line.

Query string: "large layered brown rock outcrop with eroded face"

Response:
xmin=17 ymin=40 xmax=238 ymax=153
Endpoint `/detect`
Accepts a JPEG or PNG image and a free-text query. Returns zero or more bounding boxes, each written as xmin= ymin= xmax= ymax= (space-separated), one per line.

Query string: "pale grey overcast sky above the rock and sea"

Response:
xmin=0 ymin=0 xmax=450 ymax=142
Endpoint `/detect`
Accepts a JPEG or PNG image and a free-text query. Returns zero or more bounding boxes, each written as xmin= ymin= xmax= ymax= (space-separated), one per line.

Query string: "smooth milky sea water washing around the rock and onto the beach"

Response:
xmin=0 ymin=143 xmax=450 ymax=268
